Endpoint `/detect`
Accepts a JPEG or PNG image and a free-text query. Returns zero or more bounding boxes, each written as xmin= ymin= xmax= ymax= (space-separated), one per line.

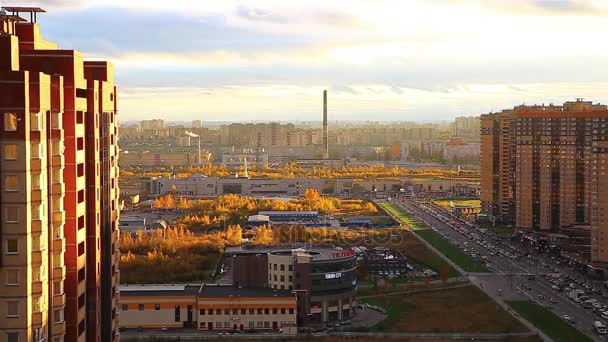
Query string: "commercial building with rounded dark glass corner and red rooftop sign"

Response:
xmin=225 ymin=244 xmax=357 ymax=325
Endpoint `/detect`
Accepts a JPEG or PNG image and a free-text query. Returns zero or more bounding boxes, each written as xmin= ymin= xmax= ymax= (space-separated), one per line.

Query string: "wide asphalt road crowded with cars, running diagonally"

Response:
xmin=397 ymin=201 xmax=608 ymax=341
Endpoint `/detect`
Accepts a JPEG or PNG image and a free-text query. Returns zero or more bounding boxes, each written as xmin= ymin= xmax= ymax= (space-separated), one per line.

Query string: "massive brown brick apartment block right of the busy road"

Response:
xmin=481 ymin=99 xmax=608 ymax=263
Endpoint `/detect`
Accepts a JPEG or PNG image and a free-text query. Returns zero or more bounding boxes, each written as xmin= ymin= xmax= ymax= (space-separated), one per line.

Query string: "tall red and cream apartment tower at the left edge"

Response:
xmin=0 ymin=7 xmax=119 ymax=342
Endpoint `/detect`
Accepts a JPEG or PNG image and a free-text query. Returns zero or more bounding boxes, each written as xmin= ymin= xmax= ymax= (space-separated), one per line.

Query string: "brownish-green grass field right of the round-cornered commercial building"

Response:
xmin=363 ymin=286 xmax=528 ymax=333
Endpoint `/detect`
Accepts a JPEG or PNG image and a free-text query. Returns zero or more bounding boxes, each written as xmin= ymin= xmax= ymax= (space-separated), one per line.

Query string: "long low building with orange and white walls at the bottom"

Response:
xmin=120 ymin=284 xmax=297 ymax=334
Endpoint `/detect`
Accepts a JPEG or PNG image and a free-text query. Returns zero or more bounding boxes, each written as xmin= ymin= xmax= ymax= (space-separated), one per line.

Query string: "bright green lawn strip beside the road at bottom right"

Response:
xmin=507 ymin=301 xmax=593 ymax=342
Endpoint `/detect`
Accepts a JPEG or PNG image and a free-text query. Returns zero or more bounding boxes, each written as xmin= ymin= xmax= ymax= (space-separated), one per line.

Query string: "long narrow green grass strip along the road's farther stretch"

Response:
xmin=380 ymin=203 xmax=490 ymax=272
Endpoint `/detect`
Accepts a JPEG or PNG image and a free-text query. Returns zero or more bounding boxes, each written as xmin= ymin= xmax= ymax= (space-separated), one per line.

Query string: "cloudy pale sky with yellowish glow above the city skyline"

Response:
xmin=7 ymin=0 xmax=608 ymax=121
